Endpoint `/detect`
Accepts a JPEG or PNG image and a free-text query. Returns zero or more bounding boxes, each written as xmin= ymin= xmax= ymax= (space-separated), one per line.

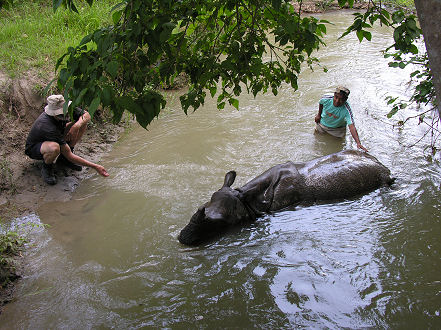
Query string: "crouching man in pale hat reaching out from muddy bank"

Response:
xmin=25 ymin=95 xmax=109 ymax=185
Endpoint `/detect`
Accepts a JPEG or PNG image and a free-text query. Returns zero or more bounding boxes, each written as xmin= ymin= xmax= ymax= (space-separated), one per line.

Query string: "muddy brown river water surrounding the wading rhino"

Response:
xmin=0 ymin=13 xmax=441 ymax=329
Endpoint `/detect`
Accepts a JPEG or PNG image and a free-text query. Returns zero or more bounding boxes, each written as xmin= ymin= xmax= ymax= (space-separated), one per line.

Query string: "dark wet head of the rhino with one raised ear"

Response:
xmin=178 ymin=171 xmax=253 ymax=245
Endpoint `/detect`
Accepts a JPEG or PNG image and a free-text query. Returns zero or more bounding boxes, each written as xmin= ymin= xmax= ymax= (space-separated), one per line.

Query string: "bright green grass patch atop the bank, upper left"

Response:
xmin=0 ymin=0 xmax=118 ymax=78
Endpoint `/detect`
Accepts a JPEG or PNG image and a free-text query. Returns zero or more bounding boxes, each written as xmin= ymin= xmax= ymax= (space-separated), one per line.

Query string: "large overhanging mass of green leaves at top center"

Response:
xmin=49 ymin=0 xmax=326 ymax=127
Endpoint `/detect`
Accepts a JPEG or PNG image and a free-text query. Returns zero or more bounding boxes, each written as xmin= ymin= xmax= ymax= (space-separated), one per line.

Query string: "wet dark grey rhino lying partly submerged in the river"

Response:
xmin=178 ymin=150 xmax=394 ymax=246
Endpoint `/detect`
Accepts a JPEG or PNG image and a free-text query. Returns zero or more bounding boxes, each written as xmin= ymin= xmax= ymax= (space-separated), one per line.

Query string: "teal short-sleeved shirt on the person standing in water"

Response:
xmin=319 ymin=95 xmax=354 ymax=128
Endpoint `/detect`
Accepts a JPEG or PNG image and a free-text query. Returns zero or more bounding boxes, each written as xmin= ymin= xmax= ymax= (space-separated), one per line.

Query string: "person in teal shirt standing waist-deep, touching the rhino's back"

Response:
xmin=315 ymin=86 xmax=367 ymax=151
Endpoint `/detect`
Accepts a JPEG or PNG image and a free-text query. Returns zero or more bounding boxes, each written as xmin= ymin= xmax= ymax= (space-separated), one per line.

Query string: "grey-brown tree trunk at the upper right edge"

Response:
xmin=415 ymin=0 xmax=441 ymax=118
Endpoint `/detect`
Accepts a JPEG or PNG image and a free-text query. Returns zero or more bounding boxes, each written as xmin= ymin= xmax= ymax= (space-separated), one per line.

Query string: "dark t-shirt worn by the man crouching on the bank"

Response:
xmin=25 ymin=108 xmax=84 ymax=154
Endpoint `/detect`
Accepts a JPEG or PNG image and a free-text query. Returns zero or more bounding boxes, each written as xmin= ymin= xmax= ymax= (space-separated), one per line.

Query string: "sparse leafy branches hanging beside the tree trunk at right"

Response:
xmin=336 ymin=0 xmax=440 ymax=154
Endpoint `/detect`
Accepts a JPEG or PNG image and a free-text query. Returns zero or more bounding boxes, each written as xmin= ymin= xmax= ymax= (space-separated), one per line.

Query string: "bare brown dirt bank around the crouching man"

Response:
xmin=0 ymin=73 xmax=127 ymax=220
